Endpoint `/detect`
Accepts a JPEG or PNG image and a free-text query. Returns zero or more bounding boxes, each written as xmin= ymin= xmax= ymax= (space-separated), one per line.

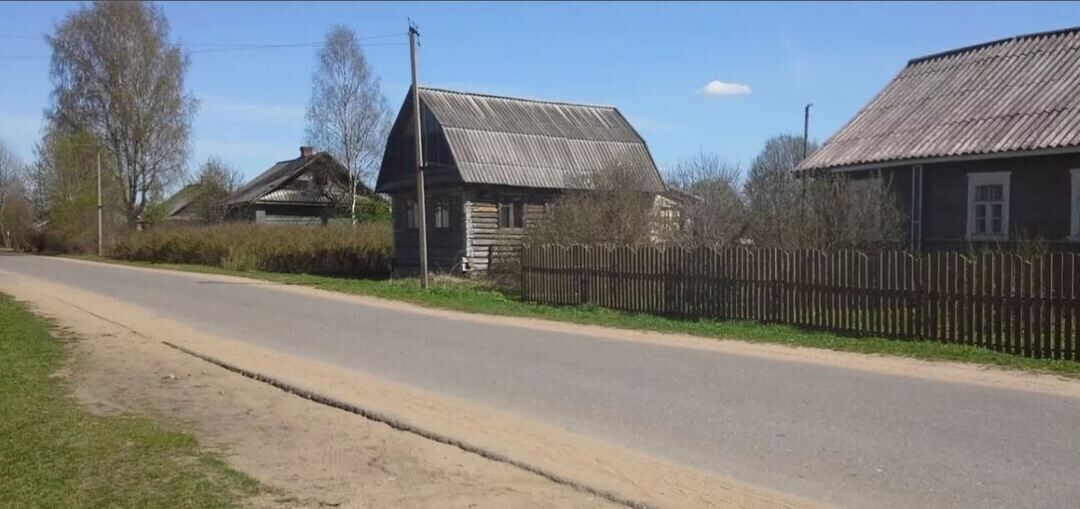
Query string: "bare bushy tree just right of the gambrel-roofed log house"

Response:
xmin=667 ymin=152 xmax=746 ymax=247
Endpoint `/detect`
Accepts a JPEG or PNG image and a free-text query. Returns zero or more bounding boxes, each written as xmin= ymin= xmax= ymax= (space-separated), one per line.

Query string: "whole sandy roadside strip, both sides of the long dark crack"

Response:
xmin=0 ymin=274 xmax=815 ymax=508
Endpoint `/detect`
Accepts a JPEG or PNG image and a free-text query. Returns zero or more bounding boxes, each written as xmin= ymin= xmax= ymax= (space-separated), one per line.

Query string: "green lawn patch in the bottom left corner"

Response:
xmin=0 ymin=294 xmax=258 ymax=508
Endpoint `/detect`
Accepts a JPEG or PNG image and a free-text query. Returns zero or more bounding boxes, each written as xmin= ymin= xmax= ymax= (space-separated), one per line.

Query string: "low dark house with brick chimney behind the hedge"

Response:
xmin=224 ymin=147 xmax=372 ymax=224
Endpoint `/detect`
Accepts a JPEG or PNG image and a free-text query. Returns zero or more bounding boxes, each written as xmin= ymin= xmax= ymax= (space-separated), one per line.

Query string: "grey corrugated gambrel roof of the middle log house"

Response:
xmin=380 ymin=86 xmax=664 ymax=192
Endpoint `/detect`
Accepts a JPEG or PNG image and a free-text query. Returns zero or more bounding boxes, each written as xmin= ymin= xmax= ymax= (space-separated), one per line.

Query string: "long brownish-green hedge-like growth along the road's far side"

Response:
xmin=110 ymin=223 xmax=392 ymax=278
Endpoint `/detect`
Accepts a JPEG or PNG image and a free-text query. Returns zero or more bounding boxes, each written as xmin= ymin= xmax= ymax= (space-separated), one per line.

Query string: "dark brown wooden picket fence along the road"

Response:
xmin=521 ymin=245 xmax=1080 ymax=361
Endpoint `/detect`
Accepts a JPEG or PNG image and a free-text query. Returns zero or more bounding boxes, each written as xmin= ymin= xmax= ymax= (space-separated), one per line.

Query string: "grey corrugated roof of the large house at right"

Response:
xmin=798 ymin=27 xmax=1080 ymax=170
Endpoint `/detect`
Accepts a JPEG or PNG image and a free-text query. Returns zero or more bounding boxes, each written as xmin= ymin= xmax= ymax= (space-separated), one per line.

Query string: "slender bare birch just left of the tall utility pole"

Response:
xmin=307 ymin=26 xmax=390 ymax=224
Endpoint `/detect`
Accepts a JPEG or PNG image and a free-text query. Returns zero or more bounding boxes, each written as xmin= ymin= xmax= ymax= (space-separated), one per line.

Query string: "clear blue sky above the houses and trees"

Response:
xmin=0 ymin=2 xmax=1080 ymax=181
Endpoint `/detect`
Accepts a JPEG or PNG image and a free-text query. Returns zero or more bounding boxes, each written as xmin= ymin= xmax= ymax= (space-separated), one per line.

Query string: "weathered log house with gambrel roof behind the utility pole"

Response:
xmin=376 ymin=88 xmax=666 ymax=271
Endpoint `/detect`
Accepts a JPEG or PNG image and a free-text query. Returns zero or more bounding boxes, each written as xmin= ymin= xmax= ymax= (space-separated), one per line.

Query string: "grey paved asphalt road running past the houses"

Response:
xmin=0 ymin=255 xmax=1080 ymax=508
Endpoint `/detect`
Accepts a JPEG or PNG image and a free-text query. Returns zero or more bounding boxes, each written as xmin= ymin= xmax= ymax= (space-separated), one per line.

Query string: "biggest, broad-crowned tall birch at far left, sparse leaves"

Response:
xmin=46 ymin=1 xmax=197 ymax=227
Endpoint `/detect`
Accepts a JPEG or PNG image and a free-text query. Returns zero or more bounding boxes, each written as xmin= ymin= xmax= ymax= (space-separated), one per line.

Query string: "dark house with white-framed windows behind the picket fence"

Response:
xmin=798 ymin=28 xmax=1080 ymax=250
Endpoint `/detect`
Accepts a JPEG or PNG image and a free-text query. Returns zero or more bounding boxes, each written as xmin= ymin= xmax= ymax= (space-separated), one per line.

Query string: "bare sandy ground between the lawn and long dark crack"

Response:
xmin=25 ymin=283 xmax=618 ymax=508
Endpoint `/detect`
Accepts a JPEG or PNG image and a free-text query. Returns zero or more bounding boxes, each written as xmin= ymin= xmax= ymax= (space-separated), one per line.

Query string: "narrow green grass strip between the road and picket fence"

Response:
xmin=71 ymin=257 xmax=1080 ymax=378
